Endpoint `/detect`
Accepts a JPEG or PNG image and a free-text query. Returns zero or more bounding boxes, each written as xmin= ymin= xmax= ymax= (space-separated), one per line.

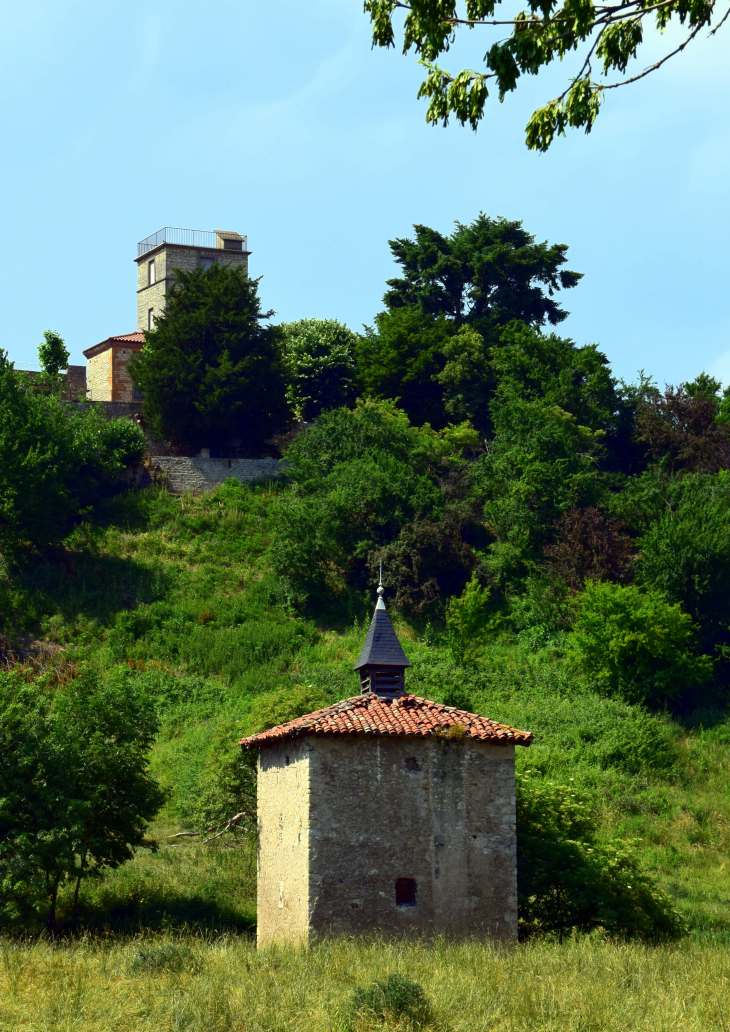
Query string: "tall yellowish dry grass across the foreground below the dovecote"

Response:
xmin=0 ymin=935 xmax=730 ymax=1032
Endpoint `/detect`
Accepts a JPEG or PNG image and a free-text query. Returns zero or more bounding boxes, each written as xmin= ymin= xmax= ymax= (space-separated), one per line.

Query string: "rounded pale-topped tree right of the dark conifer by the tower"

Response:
xmin=280 ymin=319 xmax=358 ymax=420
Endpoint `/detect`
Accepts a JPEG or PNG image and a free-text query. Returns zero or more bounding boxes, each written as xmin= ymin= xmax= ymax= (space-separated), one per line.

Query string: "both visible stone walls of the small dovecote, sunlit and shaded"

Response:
xmin=258 ymin=735 xmax=517 ymax=944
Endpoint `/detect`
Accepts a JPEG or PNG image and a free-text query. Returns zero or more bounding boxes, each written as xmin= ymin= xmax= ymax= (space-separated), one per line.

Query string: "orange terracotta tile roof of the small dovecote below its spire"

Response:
xmin=240 ymin=695 xmax=535 ymax=749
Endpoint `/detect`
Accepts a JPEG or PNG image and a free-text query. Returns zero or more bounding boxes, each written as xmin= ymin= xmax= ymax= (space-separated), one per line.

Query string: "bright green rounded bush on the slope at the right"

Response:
xmin=570 ymin=581 xmax=712 ymax=705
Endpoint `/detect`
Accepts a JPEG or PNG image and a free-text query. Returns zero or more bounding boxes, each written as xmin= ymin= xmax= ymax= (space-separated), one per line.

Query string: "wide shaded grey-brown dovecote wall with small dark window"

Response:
xmin=309 ymin=736 xmax=517 ymax=940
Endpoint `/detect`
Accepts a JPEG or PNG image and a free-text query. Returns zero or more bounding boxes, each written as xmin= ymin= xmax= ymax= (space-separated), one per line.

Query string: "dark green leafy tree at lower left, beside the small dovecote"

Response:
xmin=0 ymin=673 xmax=163 ymax=928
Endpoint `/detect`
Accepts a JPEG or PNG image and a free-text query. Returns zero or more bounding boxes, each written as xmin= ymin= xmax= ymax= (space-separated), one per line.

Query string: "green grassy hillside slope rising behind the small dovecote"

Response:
xmin=2 ymin=482 xmax=730 ymax=936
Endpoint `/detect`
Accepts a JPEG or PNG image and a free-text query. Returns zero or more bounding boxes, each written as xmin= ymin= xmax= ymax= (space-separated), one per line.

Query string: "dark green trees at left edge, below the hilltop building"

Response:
xmin=0 ymin=352 xmax=144 ymax=551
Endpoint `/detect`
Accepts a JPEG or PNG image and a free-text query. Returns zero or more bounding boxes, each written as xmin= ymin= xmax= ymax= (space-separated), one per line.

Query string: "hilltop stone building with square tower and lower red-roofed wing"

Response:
xmin=84 ymin=226 xmax=250 ymax=401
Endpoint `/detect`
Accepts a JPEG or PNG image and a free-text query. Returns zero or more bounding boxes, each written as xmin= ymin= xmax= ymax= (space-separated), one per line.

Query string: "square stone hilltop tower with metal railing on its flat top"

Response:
xmin=134 ymin=226 xmax=251 ymax=330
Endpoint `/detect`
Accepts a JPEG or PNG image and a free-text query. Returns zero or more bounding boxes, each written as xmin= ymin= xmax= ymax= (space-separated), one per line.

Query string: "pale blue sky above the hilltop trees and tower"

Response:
xmin=0 ymin=0 xmax=730 ymax=383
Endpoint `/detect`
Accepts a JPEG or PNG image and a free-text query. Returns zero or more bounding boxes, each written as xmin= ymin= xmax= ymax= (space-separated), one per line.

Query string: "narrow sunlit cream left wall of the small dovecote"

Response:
xmin=256 ymin=739 xmax=310 ymax=946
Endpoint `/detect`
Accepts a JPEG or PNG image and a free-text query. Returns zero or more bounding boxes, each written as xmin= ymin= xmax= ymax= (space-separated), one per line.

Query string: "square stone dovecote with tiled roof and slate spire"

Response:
xmin=241 ymin=585 xmax=533 ymax=945
